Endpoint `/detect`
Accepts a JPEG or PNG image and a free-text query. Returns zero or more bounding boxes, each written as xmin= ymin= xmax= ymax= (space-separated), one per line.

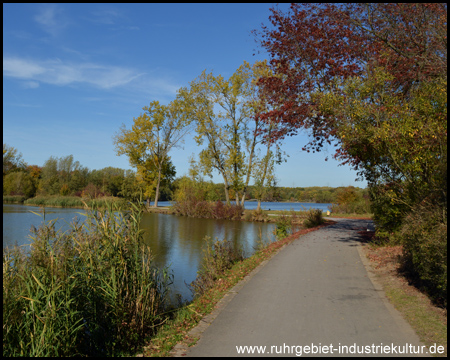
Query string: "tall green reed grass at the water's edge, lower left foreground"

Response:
xmin=3 ymin=204 xmax=172 ymax=356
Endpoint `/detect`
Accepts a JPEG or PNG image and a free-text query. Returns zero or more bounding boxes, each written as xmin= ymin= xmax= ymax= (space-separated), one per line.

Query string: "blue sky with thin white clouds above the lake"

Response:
xmin=3 ymin=4 xmax=367 ymax=187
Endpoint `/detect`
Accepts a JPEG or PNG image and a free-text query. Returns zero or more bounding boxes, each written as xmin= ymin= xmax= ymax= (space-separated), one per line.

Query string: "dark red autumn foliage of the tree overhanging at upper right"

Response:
xmin=254 ymin=3 xmax=447 ymax=168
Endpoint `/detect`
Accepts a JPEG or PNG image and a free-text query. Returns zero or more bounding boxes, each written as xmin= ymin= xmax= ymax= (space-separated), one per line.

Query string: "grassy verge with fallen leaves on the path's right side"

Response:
xmin=363 ymin=240 xmax=447 ymax=357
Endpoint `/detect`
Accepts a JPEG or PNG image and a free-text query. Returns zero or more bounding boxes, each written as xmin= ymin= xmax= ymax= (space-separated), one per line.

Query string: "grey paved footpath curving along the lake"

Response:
xmin=178 ymin=219 xmax=426 ymax=357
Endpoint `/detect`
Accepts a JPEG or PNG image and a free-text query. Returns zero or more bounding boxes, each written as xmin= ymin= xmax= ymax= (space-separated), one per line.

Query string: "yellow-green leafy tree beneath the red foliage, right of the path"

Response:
xmin=317 ymin=68 xmax=447 ymax=211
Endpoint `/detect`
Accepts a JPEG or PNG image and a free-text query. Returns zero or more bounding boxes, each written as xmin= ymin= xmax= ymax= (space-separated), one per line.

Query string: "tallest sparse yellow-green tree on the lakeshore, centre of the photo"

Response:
xmin=179 ymin=62 xmax=278 ymax=205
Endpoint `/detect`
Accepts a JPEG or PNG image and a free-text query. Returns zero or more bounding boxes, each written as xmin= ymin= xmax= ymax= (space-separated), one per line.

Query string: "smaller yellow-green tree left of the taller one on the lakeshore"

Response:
xmin=114 ymin=99 xmax=190 ymax=207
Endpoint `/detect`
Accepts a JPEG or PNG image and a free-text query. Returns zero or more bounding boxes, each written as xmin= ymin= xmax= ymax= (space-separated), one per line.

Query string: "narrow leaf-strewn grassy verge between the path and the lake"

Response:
xmin=137 ymin=221 xmax=332 ymax=356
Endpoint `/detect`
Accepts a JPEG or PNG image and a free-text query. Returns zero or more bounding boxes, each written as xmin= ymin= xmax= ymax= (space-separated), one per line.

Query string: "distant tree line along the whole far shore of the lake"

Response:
xmin=3 ymin=144 xmax=368 ymax=204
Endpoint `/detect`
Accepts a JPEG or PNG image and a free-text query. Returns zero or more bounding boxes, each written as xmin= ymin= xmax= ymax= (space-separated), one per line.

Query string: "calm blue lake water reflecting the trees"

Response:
xmin=3 ymin=202 xmax=329 ymax=300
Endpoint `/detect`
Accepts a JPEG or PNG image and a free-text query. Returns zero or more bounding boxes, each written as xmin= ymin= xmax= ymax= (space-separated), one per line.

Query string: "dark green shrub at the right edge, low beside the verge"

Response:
xmin=400 ymin=206 xmax=447 ymax=307
